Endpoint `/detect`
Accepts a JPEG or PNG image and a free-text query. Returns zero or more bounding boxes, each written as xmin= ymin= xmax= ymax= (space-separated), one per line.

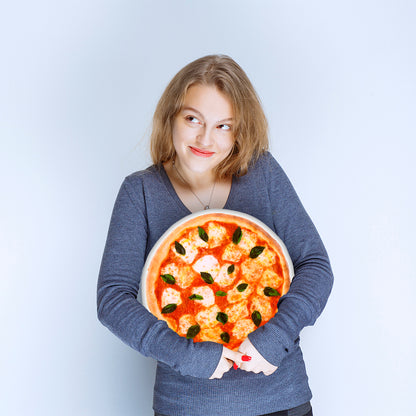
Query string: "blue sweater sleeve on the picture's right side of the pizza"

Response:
xmin=249 ymin=156 xmax=333 ymax=366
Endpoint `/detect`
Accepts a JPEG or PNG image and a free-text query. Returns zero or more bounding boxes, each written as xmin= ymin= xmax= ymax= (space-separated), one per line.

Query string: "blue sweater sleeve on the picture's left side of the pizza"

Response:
xmin=97 ymin=178 xmax=222 ymax=378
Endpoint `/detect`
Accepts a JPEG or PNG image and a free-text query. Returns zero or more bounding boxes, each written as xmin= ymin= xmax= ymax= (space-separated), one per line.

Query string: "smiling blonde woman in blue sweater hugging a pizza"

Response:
xmin=98 ymin=55 xmax=333 ymax=416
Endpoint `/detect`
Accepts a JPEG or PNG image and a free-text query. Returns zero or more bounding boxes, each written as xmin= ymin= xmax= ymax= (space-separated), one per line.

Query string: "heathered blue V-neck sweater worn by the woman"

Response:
xmin=97 ymin=153 xmax=333 ymax=416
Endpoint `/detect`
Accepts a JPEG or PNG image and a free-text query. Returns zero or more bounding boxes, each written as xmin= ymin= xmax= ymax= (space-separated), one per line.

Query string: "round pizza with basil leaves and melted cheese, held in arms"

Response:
xmin=142 ymin=210 xmax=294 ymax=350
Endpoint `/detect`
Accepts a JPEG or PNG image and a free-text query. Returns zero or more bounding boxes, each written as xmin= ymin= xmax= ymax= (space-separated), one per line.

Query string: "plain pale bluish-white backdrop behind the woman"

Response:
xmin=0 ymin=0 xmax=416 ymax=416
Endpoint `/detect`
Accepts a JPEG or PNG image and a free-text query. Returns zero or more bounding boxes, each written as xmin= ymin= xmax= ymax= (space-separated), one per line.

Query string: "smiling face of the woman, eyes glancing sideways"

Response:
xmin=172 ymin=85 xmax=234 ymax=174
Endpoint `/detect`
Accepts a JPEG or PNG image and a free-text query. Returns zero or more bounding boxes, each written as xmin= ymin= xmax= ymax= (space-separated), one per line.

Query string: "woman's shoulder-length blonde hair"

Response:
xmin=150 ymin=55 xmax=269 ymax=178
